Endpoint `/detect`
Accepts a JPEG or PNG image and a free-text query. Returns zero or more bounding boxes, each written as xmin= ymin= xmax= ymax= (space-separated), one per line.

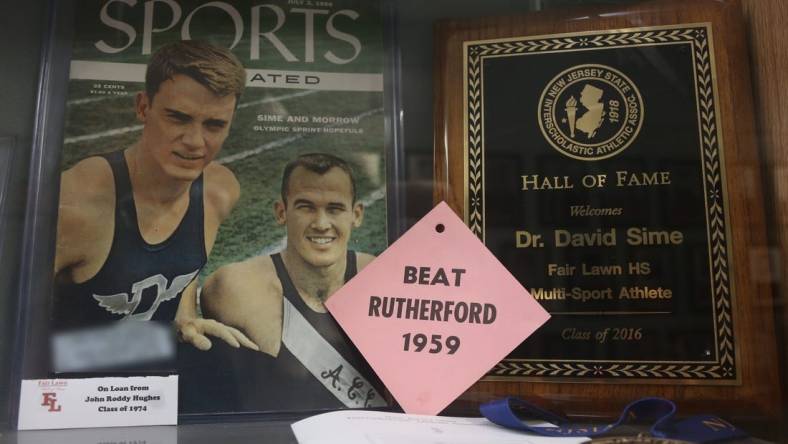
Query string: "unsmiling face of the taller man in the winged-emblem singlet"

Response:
xmin=136 ymin=74 xmax=235 ymax=181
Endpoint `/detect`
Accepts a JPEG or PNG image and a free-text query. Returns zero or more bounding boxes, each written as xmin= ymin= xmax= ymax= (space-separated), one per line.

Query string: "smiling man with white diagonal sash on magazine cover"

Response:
xmin=181 ymin=153 xmax=385 ymax=412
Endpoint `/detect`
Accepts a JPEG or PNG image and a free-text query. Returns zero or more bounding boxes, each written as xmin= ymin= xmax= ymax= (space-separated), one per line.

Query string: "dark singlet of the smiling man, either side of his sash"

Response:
xmin=178 ymin=251 xmax=382 ymax=414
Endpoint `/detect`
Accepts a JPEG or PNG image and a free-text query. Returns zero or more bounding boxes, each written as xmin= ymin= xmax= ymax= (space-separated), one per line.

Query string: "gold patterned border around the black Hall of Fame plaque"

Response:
xmin=464 ymin=23 xmax=739 ymax=380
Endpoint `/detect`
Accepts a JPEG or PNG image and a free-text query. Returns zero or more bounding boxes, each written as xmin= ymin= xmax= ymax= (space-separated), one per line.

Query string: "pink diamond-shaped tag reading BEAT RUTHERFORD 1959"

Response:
xmin=326 ymin=203 xmax=550 ymax=415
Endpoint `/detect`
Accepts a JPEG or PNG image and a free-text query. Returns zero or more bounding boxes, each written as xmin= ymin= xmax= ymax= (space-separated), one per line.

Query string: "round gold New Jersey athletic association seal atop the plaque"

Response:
xmin=538 ymin=64 xmax=643 ymax=161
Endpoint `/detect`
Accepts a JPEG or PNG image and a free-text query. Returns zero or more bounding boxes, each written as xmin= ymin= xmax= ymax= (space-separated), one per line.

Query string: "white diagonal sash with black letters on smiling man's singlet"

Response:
xmin=282 ymin=298 xmax=386 ymax=408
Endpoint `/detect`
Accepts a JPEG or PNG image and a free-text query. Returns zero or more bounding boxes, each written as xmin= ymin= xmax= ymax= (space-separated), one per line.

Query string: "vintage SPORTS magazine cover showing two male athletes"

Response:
xmin=52 ymin=0 xmax=387 ymax=414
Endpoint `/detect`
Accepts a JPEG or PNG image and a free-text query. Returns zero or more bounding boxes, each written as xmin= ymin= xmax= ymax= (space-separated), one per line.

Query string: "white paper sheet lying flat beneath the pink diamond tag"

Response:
xmin=292 ymin=410 xmax=588 ymax=444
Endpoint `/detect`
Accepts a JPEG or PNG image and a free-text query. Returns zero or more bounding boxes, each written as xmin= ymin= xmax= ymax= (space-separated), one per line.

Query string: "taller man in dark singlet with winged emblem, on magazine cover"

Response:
xmin=53 ymin=41 xmax=257 ymax=349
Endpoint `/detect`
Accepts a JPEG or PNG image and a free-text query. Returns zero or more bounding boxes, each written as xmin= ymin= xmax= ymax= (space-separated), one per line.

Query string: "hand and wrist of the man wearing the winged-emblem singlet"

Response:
xmin=175 ymin=280 xmax=259 ymax=350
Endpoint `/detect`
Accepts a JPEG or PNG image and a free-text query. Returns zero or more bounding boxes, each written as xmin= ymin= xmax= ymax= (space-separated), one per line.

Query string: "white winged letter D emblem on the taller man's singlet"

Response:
xmin=93 ymin=269 xmax=200 ymax=321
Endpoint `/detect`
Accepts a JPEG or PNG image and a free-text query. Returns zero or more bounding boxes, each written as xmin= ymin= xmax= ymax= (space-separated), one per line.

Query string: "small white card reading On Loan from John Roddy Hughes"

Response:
xmin=17 ymin=375 xmax=178 ymax=430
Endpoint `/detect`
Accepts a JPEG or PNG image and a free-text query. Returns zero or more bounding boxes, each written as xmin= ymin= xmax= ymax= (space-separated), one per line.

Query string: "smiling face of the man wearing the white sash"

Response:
xmin=274 ymin=166 xmax=364 ymax=267
